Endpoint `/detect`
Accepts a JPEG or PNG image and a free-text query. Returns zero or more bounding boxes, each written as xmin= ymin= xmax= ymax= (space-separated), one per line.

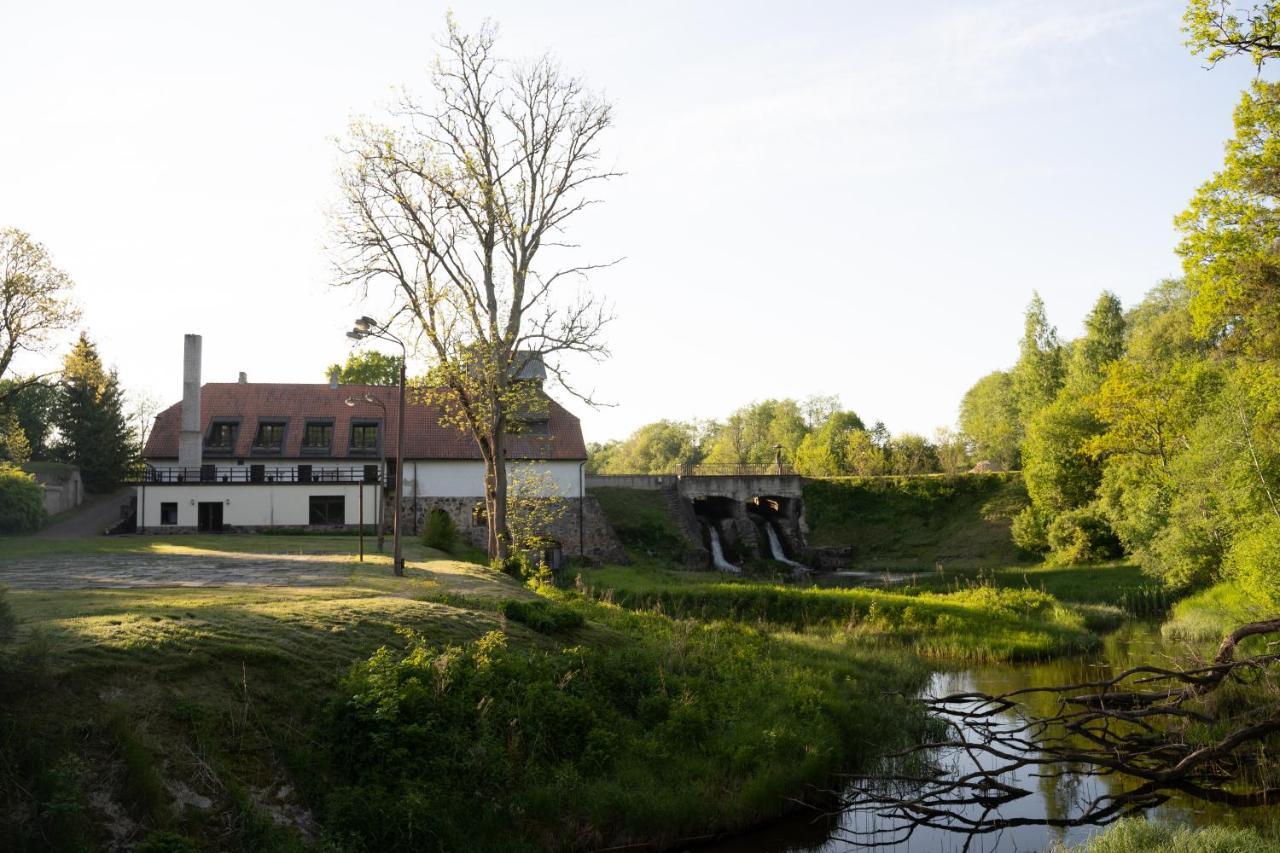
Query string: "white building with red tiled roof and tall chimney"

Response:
xmin=136 ymin=334 xmax=616 ymax=553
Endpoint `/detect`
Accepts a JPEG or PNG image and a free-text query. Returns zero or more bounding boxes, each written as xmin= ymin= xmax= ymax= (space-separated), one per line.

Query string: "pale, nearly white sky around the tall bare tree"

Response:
xmin=0 ymin=0 xmax=1252 ymax=441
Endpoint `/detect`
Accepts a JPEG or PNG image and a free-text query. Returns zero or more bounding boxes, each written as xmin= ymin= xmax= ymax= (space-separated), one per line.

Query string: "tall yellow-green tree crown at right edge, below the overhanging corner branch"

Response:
xmin=1176 ymin=79 xmax=1280 ymax=359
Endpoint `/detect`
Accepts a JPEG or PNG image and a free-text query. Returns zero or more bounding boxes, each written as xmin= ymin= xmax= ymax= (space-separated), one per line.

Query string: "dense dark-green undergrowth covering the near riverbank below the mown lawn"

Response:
xmin=321 ymin=593 xmax=925 ymax=853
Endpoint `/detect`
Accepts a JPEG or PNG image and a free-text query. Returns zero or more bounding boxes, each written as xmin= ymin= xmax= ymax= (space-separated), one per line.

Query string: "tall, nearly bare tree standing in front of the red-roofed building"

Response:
xmin=335 ymin=18 xmax=617 ymax=558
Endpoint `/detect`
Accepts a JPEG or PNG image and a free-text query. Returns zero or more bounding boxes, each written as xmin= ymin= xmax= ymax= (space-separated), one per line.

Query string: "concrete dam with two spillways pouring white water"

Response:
xmin=586 ymin=474 xmax=808 ymax=573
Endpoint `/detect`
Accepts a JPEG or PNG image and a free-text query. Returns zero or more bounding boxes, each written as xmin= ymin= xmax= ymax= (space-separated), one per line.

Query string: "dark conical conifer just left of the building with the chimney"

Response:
xmin=54 ymin=333 xmax=138 ymax=492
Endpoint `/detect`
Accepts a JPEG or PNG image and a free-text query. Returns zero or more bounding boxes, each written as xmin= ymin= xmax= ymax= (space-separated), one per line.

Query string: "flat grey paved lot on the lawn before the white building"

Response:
xmin=0 ymin=553 xmax=352 ymax=589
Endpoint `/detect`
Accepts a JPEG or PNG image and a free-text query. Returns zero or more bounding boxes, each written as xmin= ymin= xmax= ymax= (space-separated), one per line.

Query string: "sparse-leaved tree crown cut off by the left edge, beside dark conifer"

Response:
xmin=0 ymin=228 xmax=79 ymax=403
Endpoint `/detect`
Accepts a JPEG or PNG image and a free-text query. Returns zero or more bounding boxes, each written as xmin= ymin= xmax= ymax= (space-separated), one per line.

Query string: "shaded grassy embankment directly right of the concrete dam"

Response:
xmin=804 ymin=474 xmax=1027 ymax=570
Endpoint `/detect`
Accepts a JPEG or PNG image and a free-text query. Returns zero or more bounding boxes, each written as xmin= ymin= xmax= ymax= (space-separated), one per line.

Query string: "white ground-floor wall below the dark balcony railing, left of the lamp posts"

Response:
xmin=137 ymin=483 xmax=380 ymax=530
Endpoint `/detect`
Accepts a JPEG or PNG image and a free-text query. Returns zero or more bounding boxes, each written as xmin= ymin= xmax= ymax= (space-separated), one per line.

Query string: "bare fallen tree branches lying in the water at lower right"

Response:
xmin=814 ymin=619 xmax=1280 ymax=850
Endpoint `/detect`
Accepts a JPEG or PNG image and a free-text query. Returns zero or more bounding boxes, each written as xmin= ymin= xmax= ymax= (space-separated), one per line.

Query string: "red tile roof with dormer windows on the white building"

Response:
xmin=142 ymin=382 xmax=586 ymax=461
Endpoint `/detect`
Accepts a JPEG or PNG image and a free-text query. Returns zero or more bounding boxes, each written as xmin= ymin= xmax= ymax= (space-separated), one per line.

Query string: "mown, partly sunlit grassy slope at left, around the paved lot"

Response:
xmin=0 ymin=537 xmax=547 ymax=849
